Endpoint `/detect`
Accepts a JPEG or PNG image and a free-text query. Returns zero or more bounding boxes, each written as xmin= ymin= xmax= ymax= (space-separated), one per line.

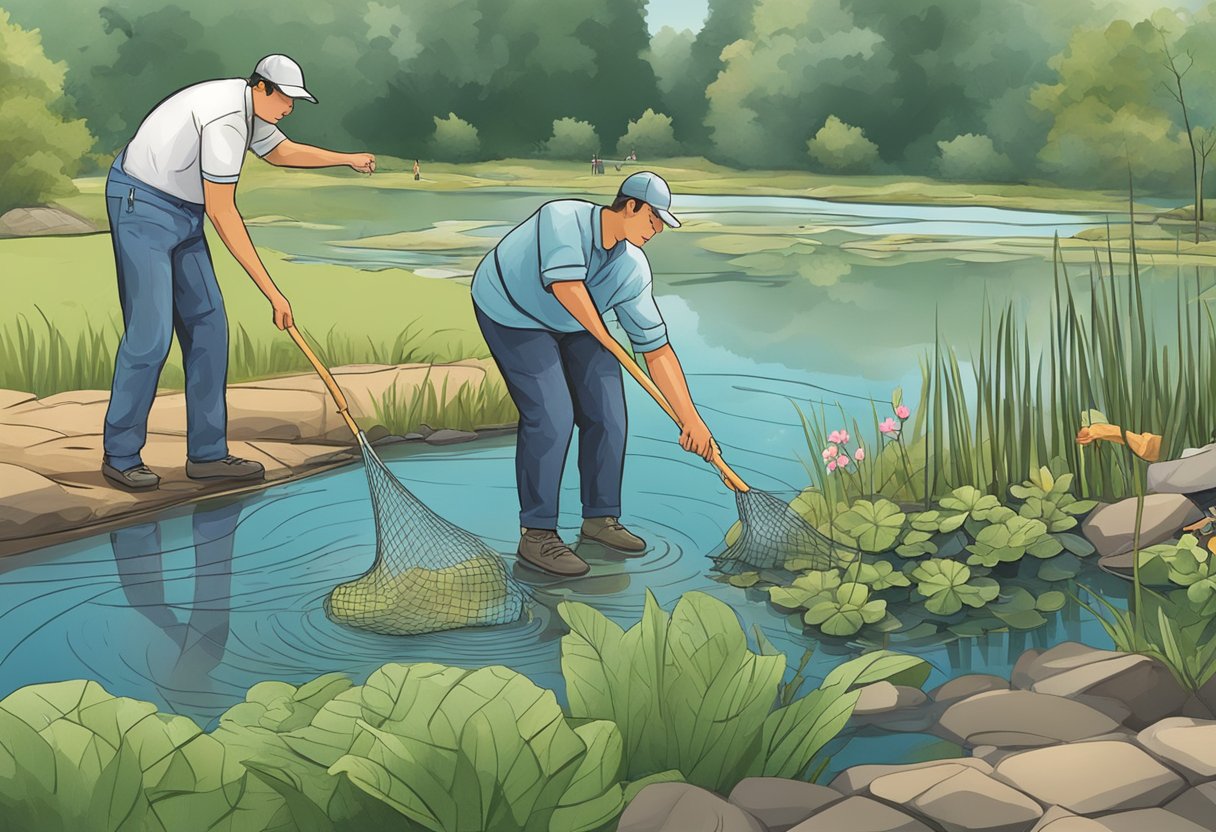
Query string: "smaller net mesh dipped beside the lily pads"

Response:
xmin=714 ymin=488 xmax=860 ymax=574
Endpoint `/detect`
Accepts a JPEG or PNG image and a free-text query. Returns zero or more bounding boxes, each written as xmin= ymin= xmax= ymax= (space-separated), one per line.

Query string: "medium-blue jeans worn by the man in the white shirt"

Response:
xmin=103 ymin=153 xmax=227 ymax=471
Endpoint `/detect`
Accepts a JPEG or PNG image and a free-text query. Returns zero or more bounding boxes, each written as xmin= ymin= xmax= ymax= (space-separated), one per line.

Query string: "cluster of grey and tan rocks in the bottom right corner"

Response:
xmin=619 ymin=642 xmax=1216 ymax=832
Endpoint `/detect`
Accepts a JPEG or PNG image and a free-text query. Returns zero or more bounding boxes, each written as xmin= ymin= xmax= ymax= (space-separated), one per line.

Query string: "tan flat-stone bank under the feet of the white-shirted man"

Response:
xmin=0 ymin=360 xmax=513 ymax=556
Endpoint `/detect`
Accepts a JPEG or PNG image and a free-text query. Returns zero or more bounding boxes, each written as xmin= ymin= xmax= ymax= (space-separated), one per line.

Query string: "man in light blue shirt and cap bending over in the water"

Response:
xmin=472 ymin=172 xmax=716 ymax=577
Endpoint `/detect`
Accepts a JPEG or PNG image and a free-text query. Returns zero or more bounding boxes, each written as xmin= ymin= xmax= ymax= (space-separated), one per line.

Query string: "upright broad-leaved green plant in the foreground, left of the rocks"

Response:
xmin=558 ymin=588 xmax=928 ymax=793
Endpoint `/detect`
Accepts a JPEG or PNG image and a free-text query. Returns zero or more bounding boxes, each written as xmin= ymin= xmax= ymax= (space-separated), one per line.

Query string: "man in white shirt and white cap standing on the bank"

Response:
xmin=101 ymin=55 xmax=376 ymax=490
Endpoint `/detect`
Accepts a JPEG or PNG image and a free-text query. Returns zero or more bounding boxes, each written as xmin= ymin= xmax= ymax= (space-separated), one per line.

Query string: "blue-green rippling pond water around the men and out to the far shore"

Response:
xmin=0 ymin=190 xmax=1147 ymax=770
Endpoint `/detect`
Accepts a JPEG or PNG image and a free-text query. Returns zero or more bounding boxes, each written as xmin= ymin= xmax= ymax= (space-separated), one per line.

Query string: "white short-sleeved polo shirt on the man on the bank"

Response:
xmin=123 ymin=78 xmax=287 ymax=204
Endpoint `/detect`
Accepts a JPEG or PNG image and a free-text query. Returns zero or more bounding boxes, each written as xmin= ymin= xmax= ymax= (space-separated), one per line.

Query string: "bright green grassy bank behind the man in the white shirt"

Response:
xmin=0 ymin=228 xmax=510 ymax=413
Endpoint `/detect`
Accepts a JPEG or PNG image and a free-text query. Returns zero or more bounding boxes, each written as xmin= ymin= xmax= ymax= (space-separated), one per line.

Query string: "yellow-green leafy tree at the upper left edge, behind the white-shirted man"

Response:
xmin=0 ymin=9 xmax=92 ymax=213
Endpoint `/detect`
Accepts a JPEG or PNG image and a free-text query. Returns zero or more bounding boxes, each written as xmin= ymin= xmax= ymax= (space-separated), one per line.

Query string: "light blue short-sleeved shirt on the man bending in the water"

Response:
xmin=473 ymin=199 xmax=668 ymax=353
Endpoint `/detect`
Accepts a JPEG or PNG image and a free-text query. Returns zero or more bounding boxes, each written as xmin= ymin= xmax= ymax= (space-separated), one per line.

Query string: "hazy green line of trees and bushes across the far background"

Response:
xmin=0 ymin=0 xmax=1216 ymax=211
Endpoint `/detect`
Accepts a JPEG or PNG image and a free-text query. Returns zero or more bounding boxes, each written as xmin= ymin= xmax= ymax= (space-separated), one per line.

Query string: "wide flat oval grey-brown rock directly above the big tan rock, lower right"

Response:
xmin=936 ymin=691 xmax=1119 ymax=747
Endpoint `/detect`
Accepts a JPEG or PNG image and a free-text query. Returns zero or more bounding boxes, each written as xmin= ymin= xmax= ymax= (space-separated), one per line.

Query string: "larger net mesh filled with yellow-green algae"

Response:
xmin=325 ymin=433 xmax=527 ymax=635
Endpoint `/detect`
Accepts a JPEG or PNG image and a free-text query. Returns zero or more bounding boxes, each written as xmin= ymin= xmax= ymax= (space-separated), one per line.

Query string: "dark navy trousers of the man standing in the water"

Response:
xmin=474 ymin=304 xmax=627 ymax=529
